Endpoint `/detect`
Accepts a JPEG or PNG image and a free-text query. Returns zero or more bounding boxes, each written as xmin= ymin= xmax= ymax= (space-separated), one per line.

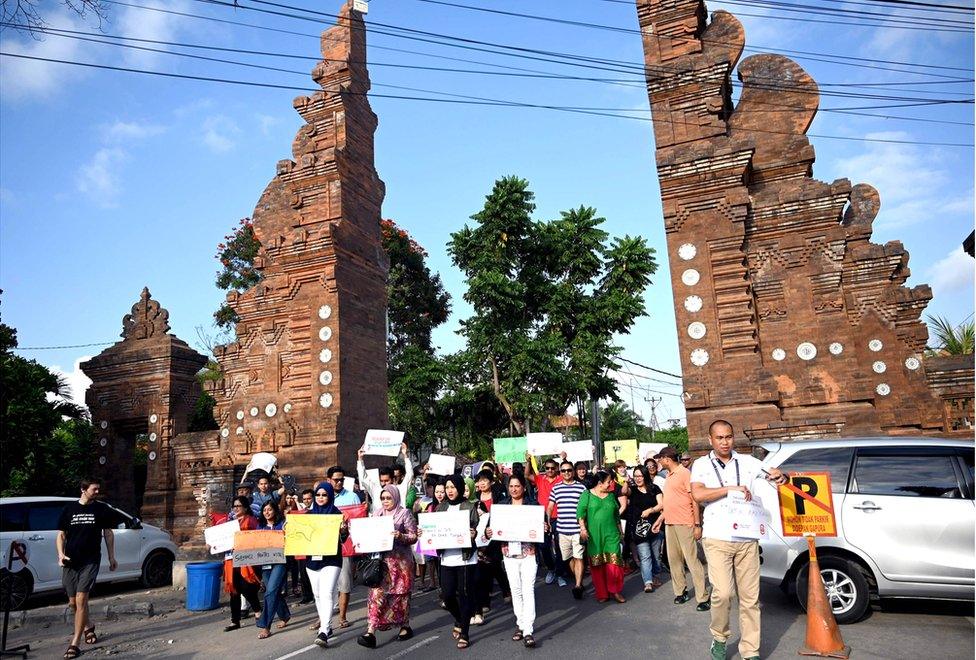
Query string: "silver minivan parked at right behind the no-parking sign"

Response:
xmin=756 ymin=438 xmax=976 ymax=623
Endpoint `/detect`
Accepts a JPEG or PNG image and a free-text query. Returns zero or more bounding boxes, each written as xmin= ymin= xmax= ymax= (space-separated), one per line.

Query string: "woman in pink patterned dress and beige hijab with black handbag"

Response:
xmin=356 ymin=484 xmax=417 ymax=649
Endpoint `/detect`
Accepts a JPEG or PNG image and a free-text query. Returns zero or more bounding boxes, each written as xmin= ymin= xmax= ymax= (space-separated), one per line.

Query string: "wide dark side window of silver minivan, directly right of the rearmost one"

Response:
xmin=854 ymin=454 xmax=962 ymax=498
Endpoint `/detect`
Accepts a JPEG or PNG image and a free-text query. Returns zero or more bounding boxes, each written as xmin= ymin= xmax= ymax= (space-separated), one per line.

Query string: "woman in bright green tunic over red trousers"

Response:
xmin=576 ymin=470 xmax=627 ymax=603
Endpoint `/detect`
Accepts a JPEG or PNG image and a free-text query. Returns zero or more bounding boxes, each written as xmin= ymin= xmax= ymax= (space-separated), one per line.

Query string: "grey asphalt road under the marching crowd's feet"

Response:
xmin=8 ymin=575 xmax=974 ymax=660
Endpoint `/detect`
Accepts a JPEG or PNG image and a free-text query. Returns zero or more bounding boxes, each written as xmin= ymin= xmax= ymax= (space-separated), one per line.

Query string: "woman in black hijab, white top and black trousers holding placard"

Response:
xmin=420 ymin=474 xmax=478 ymax=649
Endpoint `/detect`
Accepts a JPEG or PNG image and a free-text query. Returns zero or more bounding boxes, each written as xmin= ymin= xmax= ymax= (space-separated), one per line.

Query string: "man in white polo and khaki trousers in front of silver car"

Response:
xmin=691 ymin=420 xmax=788 ymax=660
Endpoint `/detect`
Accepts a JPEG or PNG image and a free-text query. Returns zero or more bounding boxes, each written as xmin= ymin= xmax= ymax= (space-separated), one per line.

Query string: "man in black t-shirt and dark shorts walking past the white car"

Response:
xmin=57 ymin=480 xmax=117 ymax=658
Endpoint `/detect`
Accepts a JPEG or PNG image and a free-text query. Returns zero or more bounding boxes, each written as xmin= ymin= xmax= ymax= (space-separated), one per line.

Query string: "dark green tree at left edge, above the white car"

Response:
xmin=0 ymin=323 xmax=94 ymax=496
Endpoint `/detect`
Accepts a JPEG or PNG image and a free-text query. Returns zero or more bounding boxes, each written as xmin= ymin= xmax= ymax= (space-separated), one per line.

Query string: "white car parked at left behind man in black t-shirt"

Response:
xmin=0 ymin=497 xmax=176 ymax=595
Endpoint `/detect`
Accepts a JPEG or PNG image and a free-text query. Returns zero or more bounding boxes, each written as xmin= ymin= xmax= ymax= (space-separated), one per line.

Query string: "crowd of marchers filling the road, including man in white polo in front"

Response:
xmin=208 ymin=421 xmax=785 ymax=658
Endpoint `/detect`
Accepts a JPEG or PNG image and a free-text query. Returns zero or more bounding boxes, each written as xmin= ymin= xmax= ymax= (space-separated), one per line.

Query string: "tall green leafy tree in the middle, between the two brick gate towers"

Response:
xmin=448 ymin=176 xmax=657 ymax=433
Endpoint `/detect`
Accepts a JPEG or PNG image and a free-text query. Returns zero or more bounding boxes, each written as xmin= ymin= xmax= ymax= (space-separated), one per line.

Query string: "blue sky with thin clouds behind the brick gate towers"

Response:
xmin=0 ymin=0 xmax=974 ymax=422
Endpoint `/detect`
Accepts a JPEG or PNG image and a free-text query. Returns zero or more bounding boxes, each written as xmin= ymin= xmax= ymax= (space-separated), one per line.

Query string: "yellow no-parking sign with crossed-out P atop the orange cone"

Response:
xmin=779 ymin=472 xmax=837 ymax=536
